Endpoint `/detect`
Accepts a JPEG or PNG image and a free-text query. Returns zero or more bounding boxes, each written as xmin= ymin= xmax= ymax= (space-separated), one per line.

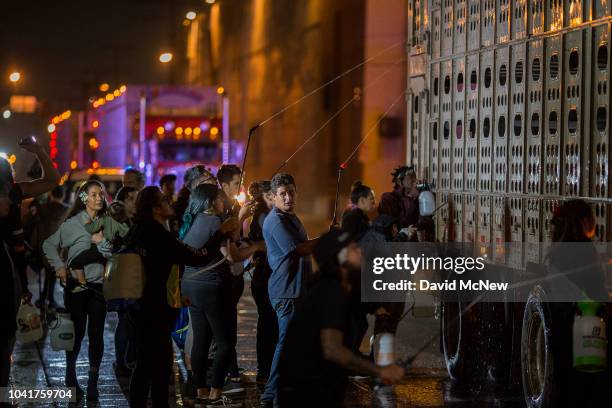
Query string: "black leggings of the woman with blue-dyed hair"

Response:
xmin=183 ymin=280 xmax=234 ymax=388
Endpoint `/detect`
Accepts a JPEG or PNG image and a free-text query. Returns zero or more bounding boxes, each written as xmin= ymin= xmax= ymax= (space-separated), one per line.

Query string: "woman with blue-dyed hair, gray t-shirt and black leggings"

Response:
xmin=179 ymin=184 xmax=265 ymax=406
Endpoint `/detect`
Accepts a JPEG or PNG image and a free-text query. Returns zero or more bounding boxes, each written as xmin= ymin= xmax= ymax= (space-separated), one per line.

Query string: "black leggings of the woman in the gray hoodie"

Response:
xmin=64 ymin=284 xmax=106 ymax=369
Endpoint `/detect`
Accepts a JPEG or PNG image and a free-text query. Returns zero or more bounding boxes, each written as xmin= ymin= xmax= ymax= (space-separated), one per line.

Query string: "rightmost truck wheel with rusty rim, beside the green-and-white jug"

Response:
xmin=521 ymin=286 xmax=573 ymax=408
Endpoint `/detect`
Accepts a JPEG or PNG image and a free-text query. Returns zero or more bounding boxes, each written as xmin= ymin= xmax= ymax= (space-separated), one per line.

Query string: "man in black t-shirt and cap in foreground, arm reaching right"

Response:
xmin=278 ymin=230 xmax=404 ymax=408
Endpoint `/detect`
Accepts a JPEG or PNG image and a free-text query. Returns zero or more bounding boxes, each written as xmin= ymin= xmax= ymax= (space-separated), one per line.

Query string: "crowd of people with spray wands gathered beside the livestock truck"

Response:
xmin=0 ymin=144 xmax=604 ymax=407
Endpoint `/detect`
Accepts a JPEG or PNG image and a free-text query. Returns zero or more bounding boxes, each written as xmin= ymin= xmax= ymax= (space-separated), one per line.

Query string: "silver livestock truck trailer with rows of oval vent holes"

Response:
xmin=407 ymin=0 xmax=612 ymax=407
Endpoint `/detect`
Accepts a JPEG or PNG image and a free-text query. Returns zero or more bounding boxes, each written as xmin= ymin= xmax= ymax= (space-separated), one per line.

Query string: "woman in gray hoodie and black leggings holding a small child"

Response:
xmin=43 ymin=180 xmax=111 ymax=401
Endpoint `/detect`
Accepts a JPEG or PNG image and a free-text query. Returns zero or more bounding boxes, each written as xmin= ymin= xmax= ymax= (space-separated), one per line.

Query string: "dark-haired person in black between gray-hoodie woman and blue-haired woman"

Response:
xmin=127 ymin=186 xmax=237 ymax=407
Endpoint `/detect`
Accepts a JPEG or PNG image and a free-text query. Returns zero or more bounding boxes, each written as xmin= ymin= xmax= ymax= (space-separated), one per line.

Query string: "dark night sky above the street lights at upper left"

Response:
xmin=0 ymin=0 xmax=198 ymax=109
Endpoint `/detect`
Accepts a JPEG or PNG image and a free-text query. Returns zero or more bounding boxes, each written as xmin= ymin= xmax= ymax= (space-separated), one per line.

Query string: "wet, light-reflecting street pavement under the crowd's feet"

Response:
xmin=5 ymin=270 xmax=525 ymax=408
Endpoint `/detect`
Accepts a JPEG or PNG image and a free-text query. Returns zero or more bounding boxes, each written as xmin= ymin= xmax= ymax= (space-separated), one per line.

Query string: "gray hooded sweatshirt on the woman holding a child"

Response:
xmin=43 ymin=211 xmax=111 ymax=289
